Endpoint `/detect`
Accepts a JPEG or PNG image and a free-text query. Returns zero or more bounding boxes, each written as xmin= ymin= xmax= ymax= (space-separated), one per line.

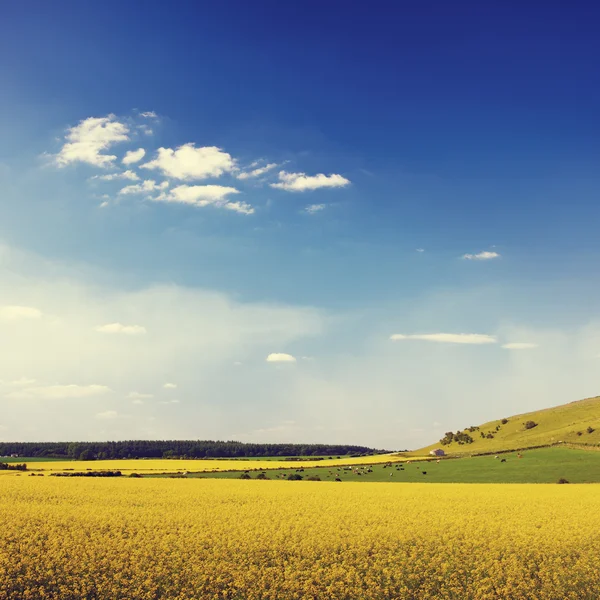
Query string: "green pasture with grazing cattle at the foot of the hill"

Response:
xmin=148 ymin=448 xmax=600 ymax=483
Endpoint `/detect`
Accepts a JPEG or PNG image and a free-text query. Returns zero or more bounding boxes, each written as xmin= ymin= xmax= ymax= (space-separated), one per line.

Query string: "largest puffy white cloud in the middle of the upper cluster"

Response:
xmin=141 ymin=143 xmax=235 ymax=181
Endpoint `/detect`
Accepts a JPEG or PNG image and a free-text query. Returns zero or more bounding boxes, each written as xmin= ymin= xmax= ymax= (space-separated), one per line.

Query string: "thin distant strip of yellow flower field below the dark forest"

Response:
xmin=21 ymin=454 xmax=410 ymax=473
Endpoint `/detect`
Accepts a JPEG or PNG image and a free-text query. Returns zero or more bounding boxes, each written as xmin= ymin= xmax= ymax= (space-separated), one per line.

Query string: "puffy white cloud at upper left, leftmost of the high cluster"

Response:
xmin=54 ymin=115 xmax=129 ymax=167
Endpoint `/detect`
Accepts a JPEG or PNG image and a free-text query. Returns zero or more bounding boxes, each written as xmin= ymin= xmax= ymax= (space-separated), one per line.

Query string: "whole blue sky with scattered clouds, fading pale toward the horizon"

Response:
xmin=0 ymin=1 xmax=600 ymax=448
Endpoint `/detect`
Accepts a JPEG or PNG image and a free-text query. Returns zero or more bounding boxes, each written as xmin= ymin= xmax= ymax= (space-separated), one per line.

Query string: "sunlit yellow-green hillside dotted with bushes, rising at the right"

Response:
xmin=409 ymin=396 xmax=600 ymax=456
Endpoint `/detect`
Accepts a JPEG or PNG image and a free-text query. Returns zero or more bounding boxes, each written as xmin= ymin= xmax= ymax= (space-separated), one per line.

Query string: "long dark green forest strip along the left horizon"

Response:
xmin=0 ymin=440 xmax=384 ymax=460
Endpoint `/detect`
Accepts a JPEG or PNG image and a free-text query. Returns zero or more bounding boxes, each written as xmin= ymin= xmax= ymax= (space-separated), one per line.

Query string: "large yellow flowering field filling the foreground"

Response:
xmin=0 ymin=474 xmax=600 ymax=600
